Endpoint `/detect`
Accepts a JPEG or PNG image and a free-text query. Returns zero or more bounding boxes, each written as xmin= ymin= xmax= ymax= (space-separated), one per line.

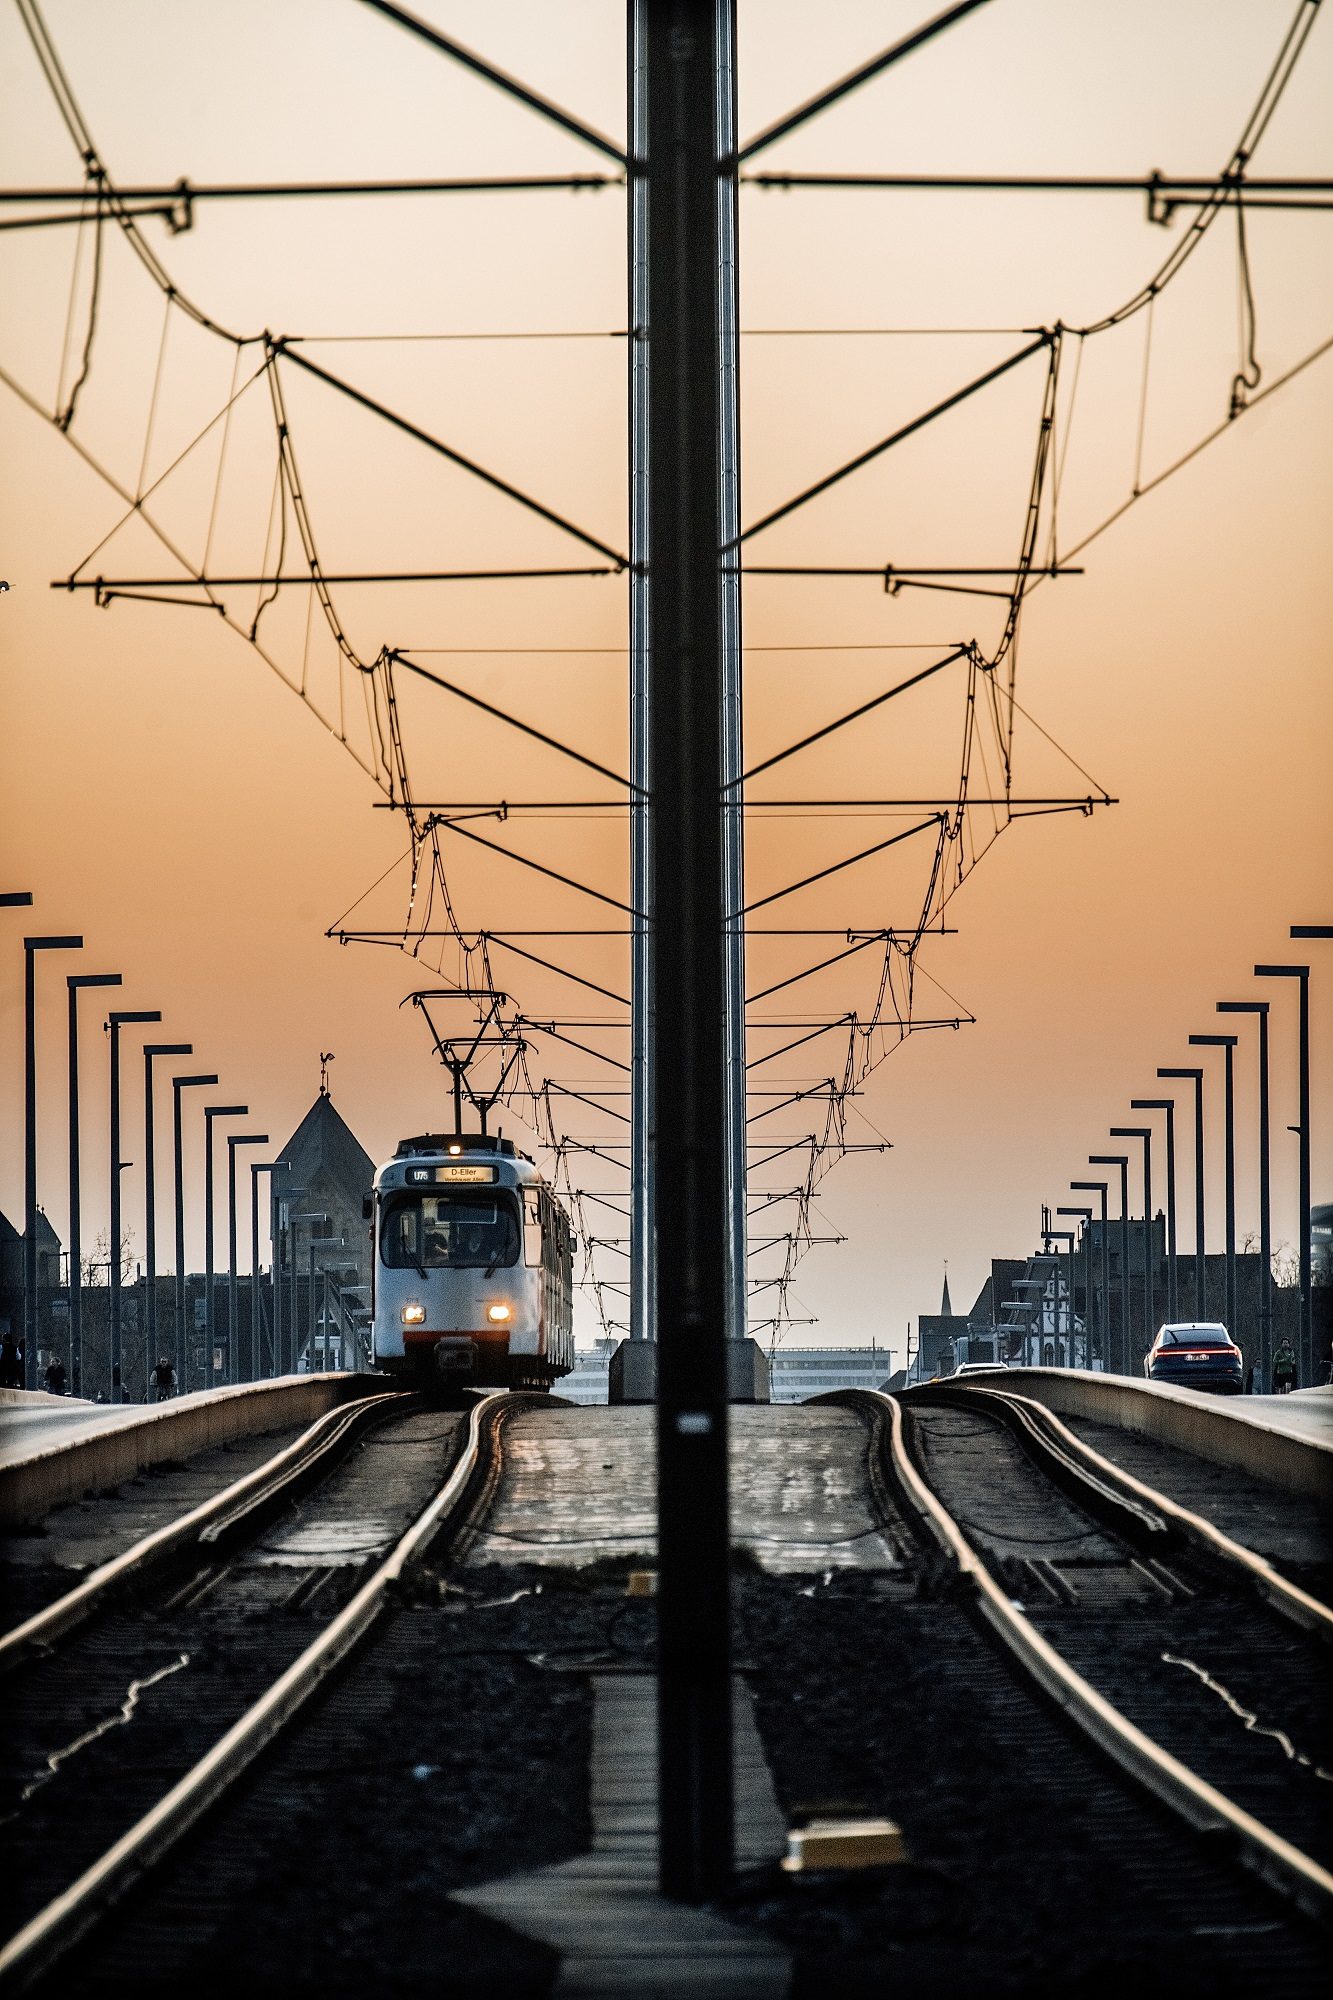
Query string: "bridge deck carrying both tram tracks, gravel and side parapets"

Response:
xmin=0 ymin=1368 xmax=1333 ymax=1996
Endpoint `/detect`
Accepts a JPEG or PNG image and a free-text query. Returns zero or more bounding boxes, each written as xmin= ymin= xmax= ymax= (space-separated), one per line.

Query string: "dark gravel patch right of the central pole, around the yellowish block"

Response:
xmin=721 ymin=1574 xmax=1327 ymax=2000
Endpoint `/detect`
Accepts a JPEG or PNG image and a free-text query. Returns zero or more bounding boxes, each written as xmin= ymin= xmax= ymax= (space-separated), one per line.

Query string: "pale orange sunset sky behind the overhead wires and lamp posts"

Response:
xmin=0 ymin=0 xmax=1333 ymax=1358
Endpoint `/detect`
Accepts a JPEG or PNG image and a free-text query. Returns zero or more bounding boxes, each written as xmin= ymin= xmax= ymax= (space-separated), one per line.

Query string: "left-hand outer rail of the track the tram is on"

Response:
xmin=0 ymin=1394 xmax=402 ymax=1674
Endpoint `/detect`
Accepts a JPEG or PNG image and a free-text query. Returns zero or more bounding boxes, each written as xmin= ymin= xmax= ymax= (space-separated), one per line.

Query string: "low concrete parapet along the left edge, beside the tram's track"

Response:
xmin=0 ymin=1372 xmax=390 ymax=1528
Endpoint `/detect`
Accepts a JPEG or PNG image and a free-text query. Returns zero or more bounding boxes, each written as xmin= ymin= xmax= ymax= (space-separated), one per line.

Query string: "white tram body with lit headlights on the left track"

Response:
xmin=366 ymin=1132 xmax=574 ymax=1388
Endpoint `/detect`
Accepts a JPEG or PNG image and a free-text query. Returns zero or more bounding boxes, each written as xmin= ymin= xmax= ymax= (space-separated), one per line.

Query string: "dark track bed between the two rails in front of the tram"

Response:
xmin=0 ymin=1412 xmax=462 ymax=1930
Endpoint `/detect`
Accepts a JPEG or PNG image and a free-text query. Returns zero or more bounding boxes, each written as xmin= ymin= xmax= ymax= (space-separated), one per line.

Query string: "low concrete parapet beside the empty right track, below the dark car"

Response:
xmin=996 ymin=1368 xmax=1333 ymax=1508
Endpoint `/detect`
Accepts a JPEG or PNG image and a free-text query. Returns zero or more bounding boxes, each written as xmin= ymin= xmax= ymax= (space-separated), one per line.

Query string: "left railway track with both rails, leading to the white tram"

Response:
xmin=0 ymin=1396 xmax=526 ymax=1990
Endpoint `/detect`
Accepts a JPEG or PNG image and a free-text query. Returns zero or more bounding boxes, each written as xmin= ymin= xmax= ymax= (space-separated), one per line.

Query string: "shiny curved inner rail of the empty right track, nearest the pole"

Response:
xmin=847 ymin=1390 xmax=1333 ymax=1922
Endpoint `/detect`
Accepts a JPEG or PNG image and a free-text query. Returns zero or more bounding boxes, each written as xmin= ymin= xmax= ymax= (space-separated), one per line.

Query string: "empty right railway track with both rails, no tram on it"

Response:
xmin=869 ymin=1386 xmax=1333 ymax=1922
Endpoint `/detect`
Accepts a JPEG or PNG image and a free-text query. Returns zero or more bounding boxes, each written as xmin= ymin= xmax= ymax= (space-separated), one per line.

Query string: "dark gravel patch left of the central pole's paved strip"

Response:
xmin=42 ymin=1562 xmax=654 ymax=2000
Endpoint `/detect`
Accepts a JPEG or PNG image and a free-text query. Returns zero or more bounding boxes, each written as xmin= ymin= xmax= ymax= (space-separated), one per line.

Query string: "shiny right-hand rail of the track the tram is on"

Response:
xmin=0 ymin=1392 xmax=516 ymax=1990
